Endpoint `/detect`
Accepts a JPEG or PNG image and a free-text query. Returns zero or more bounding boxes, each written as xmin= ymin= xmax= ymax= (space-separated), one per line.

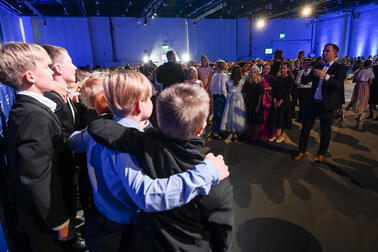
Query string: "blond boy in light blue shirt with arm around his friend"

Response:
xmin=69 ymin=71 xmax=229 ymax=251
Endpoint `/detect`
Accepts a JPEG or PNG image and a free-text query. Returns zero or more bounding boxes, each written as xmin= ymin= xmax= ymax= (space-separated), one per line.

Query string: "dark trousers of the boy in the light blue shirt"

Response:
xmin=85 ymin=210 xmax=134 ymax=252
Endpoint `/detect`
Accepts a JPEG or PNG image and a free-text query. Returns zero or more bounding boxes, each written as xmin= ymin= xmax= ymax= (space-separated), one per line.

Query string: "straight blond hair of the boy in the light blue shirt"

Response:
xmin=103 ymin=69 xmax=152 ymax=117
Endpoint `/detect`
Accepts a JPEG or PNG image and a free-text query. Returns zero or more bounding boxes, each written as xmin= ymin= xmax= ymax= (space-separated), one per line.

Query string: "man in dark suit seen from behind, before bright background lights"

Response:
xmin=156 ymin=51 xmax=185 ymax=89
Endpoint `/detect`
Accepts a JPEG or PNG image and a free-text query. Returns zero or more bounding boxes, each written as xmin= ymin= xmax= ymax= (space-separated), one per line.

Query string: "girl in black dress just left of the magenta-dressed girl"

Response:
xmin=242 ymin=67 xmax=264 ymax=140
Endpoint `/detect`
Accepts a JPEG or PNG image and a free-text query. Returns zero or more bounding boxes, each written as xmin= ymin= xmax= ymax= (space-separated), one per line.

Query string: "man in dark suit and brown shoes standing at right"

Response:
xmin=294 ymin=44 xmax=347 ymax=162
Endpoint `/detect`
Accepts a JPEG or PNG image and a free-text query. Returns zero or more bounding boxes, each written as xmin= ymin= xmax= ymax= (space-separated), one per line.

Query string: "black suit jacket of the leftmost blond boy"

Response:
xmin=8 ymin=95 xmax=69 ymax=229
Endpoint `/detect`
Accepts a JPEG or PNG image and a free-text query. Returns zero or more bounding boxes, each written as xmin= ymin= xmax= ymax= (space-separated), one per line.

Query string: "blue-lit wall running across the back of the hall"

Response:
xmin=0 ymin=4 xmax=378 ymax=65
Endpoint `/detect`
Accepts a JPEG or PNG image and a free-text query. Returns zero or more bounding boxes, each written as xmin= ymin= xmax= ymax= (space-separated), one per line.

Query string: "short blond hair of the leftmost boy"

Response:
xmin=0 ymin=42 xmax=49 ymax=90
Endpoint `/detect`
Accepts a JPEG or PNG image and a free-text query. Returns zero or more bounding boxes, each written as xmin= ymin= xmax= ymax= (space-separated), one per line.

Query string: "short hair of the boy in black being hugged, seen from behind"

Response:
xmin=156 ymin=84 xmax=210 ymax=140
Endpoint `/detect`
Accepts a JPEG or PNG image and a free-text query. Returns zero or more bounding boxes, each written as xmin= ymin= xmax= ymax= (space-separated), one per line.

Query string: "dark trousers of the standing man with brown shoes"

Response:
xmin=298 ymin=102 xmax=334 ymax=155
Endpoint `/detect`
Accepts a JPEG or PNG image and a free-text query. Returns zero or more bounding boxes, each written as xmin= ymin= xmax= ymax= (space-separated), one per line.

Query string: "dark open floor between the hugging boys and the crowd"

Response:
xmin=207 ymin=80 xmax=378 ymax=252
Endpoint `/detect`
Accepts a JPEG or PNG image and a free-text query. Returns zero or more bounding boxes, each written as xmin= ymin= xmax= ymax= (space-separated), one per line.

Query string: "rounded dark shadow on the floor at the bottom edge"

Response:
xmin=237 ymin=218 xmax=323 ymax=252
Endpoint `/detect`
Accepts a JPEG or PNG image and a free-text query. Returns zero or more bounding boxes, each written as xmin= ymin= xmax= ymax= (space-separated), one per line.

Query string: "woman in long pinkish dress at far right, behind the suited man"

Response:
xmin=346 ymin=60 xmax=374 ymax=121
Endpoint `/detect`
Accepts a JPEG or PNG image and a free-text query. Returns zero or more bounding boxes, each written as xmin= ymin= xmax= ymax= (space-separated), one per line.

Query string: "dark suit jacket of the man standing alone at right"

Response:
xmin=302 ymin=62 xmax=347 ymax=111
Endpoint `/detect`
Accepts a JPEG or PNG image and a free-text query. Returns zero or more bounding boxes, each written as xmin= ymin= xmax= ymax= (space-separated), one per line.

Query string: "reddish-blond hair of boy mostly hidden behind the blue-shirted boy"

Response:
xmin=80 ymin=72 xmax=107 ymax=109
